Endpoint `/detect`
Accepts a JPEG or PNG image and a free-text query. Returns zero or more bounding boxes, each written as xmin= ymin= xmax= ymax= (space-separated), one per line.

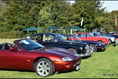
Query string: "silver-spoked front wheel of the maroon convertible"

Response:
xmin=34 ymin=58 xmax=55 ymax=76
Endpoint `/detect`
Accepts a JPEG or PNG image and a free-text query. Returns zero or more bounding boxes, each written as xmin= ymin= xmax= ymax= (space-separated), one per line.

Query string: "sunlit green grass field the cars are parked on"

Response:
xmin=0 ymin=39 xmax=118 ymax=78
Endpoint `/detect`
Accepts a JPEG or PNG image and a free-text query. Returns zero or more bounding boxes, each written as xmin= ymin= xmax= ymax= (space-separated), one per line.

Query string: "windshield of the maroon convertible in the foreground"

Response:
xmin=19 ymin=39 xmax=44 ymax=50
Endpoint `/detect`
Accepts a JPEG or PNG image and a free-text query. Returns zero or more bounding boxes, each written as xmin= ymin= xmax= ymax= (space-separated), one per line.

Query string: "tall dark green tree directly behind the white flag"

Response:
xmin=73 ymin=0 xmax=103 ymax=31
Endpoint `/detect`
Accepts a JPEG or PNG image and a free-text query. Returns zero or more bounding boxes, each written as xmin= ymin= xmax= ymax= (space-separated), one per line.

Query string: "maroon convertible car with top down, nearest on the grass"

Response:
xmin=0 ymin=39 xmax=81 ymax=76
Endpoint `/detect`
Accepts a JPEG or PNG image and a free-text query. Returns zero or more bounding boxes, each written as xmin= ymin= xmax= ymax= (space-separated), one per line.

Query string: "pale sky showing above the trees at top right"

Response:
xmin=70 ymin=0 xmax=118 ymax=12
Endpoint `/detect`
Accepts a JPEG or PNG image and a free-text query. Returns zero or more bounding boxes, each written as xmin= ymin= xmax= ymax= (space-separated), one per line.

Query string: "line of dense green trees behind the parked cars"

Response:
xmin=0 ymin=0 xmax=116 ymax=37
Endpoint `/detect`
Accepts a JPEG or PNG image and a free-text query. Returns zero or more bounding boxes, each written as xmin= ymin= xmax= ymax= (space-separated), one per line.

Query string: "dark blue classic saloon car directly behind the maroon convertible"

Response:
xmin=30 ymin=33 xmax=95 ymax=57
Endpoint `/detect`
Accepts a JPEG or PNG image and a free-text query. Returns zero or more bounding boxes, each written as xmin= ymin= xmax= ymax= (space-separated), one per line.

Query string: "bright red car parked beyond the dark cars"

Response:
xmin=74 ymin=33 xmax=110 ymax=44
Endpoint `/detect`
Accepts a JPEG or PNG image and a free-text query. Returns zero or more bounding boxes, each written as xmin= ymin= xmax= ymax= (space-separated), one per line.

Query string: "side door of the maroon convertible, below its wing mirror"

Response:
xmin=0 ymin=43 xmax=24 ymax=69
